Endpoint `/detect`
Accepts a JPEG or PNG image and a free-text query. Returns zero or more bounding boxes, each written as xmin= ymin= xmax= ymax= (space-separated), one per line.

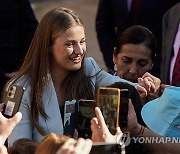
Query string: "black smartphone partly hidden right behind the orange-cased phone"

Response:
xmin=119 ymin=89 xmax=129 ymax=127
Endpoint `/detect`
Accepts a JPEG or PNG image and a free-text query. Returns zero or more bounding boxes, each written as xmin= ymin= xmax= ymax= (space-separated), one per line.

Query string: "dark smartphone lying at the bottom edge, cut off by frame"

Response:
xmin=90 ymin=143 xmax=121 ymax=154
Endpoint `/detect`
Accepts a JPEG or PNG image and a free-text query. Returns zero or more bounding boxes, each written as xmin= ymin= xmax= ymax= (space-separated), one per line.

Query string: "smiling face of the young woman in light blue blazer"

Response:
xmin=52 ymin=25 xmax=86 ymax=72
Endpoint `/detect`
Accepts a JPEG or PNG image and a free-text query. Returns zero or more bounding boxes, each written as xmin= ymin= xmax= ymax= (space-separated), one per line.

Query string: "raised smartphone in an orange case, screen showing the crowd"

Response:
xmin=97 ymin=87 xmax=120 ymax=134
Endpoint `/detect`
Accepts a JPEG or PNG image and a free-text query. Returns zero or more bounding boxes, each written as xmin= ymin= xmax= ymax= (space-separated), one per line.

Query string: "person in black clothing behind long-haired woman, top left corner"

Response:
xmin=0 ymin=0 xmax=38 ymax=95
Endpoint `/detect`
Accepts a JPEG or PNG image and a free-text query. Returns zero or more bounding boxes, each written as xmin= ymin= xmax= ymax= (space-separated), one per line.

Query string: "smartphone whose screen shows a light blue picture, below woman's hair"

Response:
xmin=64 ymin=100 xmax=78 ymax=137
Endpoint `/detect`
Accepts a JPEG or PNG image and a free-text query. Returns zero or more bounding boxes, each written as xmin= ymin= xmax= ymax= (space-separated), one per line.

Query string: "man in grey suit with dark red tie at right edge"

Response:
xmin=161 ymin=3 xmax=180 ymax=86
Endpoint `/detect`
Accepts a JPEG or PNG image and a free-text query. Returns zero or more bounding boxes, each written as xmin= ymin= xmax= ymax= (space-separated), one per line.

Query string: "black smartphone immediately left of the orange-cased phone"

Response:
xmin=77 ymin=99 xmax=96 ymax=138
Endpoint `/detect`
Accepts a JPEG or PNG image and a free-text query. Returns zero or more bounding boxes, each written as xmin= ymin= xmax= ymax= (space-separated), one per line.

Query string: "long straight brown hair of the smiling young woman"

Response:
xmin=2 ymin=7 xmax=94 ymax=135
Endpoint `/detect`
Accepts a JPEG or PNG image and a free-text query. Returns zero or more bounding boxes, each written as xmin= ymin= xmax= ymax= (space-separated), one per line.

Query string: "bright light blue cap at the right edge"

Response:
xmin=141 ymin=86 xmax=180 ymax=137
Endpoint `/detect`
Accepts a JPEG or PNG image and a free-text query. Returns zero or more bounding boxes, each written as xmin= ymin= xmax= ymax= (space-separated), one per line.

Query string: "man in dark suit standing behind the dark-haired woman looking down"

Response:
xmin=96 ymin=0 xmax=179 ymax=77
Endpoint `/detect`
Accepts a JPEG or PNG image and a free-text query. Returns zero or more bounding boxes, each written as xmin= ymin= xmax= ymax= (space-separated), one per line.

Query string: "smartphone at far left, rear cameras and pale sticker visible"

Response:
xmin=2 ymin=85 xmax=25 ymax=118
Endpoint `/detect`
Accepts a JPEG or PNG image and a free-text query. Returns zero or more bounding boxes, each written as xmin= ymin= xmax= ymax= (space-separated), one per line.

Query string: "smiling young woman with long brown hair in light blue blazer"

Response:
xmin=2 ymin=8 xmax=158 ymax=146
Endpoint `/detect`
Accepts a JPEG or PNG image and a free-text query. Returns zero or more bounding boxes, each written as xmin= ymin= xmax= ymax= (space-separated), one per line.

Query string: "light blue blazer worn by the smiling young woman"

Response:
xmin=8 ymin=57 xmax=137 ymax=146
